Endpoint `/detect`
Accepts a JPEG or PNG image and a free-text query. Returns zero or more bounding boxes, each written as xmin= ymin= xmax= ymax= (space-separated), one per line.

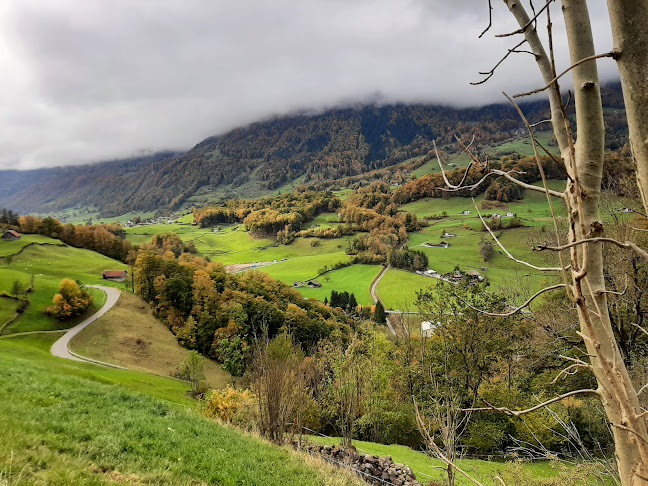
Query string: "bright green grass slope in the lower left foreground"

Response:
xmin=0 ymin=336 xmax=362 ymax=485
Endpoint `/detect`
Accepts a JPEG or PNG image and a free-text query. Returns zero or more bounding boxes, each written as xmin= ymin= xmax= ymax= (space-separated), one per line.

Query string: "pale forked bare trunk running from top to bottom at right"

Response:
xmin=504 ymin=0 xmax=648 ymax=486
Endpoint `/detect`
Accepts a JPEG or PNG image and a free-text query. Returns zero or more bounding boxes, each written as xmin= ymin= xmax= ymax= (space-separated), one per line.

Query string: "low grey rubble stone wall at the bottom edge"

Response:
xmin=293 ymin=441 xmax=422 ymax=486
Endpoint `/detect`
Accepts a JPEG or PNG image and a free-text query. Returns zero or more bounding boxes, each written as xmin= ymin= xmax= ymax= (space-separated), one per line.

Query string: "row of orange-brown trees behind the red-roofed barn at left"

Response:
xmin=18 ymin=215 xmax=133 ymax=262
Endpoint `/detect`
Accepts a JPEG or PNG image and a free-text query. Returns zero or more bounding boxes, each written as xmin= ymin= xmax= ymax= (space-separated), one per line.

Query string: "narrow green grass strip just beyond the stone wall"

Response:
xmin=309 ymin=436 xmax=612 ymax=486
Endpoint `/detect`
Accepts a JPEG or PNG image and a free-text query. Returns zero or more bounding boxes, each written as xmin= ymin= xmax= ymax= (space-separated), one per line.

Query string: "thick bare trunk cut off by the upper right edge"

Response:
xmin=608 ymin=0 xmax=648 ymax=214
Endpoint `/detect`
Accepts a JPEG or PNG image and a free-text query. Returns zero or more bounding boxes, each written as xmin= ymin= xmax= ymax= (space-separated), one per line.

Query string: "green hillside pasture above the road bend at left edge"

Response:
xmin=0 ymin=242 xmax=128 ymax=333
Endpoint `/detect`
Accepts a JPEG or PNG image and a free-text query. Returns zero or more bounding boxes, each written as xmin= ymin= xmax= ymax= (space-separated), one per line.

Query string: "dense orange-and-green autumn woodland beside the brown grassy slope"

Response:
xmin=134 ymin=245 xmax=351 ymax=376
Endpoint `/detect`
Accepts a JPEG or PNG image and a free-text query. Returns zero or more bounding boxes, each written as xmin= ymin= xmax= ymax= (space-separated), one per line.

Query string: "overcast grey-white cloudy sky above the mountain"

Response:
xmin=0 ymin=0 xmax=615 ymax=170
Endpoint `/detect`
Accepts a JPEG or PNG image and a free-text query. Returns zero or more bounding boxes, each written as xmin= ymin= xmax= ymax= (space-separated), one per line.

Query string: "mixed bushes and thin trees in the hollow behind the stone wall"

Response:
xmin=206 ymin=282 xmax=612 ymax=464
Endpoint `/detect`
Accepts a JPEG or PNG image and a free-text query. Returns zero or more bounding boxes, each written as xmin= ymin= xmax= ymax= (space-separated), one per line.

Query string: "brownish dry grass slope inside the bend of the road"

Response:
xmin=70 ymin=292 xmax=232 ymax=388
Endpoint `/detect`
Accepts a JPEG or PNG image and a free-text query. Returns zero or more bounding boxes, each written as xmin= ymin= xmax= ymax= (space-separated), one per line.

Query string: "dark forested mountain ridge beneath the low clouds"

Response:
xmin=0 ymin=85 xmax=625 ymax=216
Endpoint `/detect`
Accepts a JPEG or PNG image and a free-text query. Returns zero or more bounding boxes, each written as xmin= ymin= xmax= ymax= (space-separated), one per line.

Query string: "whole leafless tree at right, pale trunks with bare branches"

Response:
xmin=458 ymin=0 xmax=648 ymax=486
